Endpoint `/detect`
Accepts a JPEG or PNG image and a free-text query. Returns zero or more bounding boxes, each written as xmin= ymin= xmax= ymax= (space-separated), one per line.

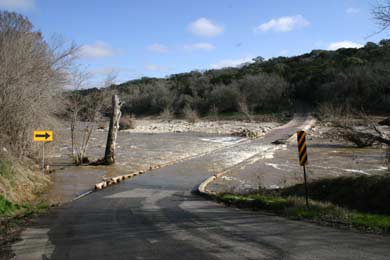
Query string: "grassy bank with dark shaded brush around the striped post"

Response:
xmin=214 ymin=175 xmax=390 ymax=234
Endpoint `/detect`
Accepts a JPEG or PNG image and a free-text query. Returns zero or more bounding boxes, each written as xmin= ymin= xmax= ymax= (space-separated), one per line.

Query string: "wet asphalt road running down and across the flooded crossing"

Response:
xmin=5 ymin=119 xmax=390 ymax=260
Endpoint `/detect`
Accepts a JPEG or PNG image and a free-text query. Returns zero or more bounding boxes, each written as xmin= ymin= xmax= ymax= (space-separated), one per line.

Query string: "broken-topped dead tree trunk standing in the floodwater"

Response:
xmin=103 ymin=95 xmax=121 ymax=165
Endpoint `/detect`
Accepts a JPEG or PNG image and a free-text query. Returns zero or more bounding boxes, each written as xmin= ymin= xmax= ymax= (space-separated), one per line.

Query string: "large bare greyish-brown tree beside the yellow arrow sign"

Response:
xmin=0 ymin=11 xmax=77 ymax=157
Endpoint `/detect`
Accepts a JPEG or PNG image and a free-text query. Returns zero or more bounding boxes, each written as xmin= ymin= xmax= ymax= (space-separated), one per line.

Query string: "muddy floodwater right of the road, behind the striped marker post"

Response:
xmin=208 ymin=128 xmax=388 ymax=193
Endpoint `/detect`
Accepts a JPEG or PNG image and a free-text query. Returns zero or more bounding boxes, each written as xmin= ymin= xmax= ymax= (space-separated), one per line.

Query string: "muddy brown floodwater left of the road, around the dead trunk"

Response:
xmin=48 ymin=130 xmax=246 ymax=203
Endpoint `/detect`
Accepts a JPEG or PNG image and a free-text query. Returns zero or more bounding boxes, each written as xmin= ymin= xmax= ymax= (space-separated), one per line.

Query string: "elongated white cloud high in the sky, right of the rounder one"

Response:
xmin=255 ymin=15 xmax=310 ymax=32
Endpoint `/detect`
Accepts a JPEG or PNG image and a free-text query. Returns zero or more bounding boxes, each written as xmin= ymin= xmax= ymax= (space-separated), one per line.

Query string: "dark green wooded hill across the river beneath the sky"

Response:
xmin=82 ymin=40 xmax=390 ymax=115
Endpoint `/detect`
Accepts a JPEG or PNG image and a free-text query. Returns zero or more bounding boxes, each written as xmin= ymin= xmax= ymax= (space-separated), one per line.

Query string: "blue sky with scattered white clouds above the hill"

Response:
xmin=0 ymin=0 xmax=389 ymax=85
